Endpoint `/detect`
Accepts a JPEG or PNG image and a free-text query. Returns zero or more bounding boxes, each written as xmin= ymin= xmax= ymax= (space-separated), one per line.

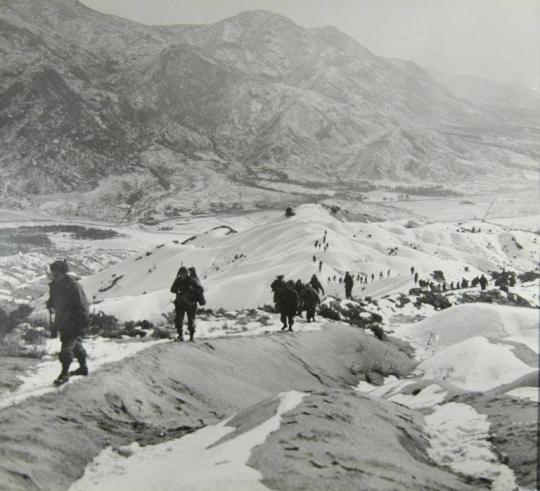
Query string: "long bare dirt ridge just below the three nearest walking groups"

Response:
xmin=0 ymin=325 xmax=414 ymax=491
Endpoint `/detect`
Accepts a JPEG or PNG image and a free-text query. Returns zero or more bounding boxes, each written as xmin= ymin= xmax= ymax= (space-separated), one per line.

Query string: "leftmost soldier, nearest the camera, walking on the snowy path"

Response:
xmin=47 ymin=261 xmax=89 ymax=385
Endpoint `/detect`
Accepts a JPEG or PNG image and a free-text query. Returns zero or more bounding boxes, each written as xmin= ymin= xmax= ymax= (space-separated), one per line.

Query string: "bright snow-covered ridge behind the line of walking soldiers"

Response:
xmin=83 ymin=205 xmax=536 ymax=320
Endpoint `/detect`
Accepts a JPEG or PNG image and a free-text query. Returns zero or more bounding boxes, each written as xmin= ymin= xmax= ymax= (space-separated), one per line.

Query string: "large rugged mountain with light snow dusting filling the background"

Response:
xmin=0 ymin=0 xmax=540 ymax=217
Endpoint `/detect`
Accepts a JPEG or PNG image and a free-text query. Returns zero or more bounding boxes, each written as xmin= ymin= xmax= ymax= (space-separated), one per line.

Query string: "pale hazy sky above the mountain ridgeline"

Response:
xmin=82 ymin=0 xmax=540 ymax=88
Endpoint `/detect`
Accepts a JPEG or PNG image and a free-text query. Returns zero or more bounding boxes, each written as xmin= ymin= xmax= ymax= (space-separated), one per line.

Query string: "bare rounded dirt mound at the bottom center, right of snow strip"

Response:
xmin=248 ymin=389 xmax=479 ymax=491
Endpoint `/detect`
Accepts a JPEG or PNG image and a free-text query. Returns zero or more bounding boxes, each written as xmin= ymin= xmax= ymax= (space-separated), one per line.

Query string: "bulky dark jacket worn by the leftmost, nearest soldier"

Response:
xmin=47 ymin=275 xmax=89 ymax=337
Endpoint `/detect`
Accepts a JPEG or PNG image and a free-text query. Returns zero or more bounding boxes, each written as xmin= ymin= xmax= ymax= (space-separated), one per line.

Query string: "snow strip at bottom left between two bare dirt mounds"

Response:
xmin=70 ymin=391 xmax=306 ymax=491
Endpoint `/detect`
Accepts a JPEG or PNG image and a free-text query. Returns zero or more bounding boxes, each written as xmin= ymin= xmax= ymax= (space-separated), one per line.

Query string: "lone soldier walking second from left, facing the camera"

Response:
xmin=171 ymin=266 xmax=202 ymax=341
